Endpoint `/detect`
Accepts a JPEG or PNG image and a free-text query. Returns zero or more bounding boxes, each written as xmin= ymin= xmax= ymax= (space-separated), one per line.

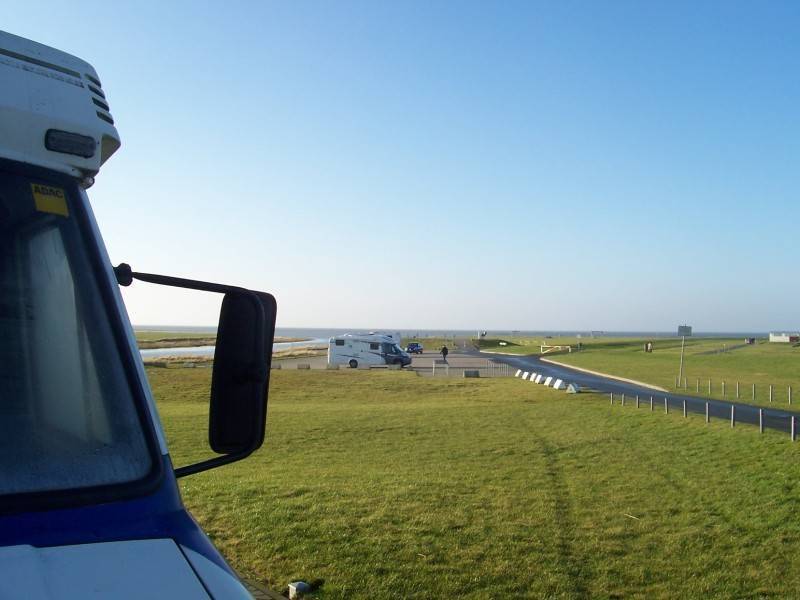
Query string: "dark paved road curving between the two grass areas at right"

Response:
xmin=481 ymin=353 xmax=800 ymax=433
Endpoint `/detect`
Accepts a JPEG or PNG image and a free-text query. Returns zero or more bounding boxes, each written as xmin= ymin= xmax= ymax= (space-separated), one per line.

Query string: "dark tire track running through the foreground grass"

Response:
xmin=531 ymin=432 xmax=594 ymax=598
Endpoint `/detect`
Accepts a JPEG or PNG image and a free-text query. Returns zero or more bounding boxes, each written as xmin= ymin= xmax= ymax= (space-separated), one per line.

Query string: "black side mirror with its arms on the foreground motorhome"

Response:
xmin=114 ymin=263 xmax=277 ymax=477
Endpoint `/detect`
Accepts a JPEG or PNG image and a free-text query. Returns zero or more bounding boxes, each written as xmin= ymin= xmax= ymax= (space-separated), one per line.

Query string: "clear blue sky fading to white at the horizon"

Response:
xmin=0 ymin=0 xmax=800 ymax=331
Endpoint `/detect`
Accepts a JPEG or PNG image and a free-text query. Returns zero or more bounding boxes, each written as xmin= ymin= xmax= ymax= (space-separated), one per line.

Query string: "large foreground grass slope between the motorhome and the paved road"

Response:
xmin=148 ymin=369 xmax=800 ymax=598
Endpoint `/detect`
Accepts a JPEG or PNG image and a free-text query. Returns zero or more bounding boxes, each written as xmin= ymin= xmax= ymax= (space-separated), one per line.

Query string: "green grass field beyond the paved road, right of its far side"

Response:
xmin=552 ymin=338 xmax=800 ymax=408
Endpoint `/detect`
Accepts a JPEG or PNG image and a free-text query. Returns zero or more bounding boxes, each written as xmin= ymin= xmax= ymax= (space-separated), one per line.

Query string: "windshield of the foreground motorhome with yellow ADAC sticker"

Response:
xmin=0 ymin=165 xmax=153 ymax=495
